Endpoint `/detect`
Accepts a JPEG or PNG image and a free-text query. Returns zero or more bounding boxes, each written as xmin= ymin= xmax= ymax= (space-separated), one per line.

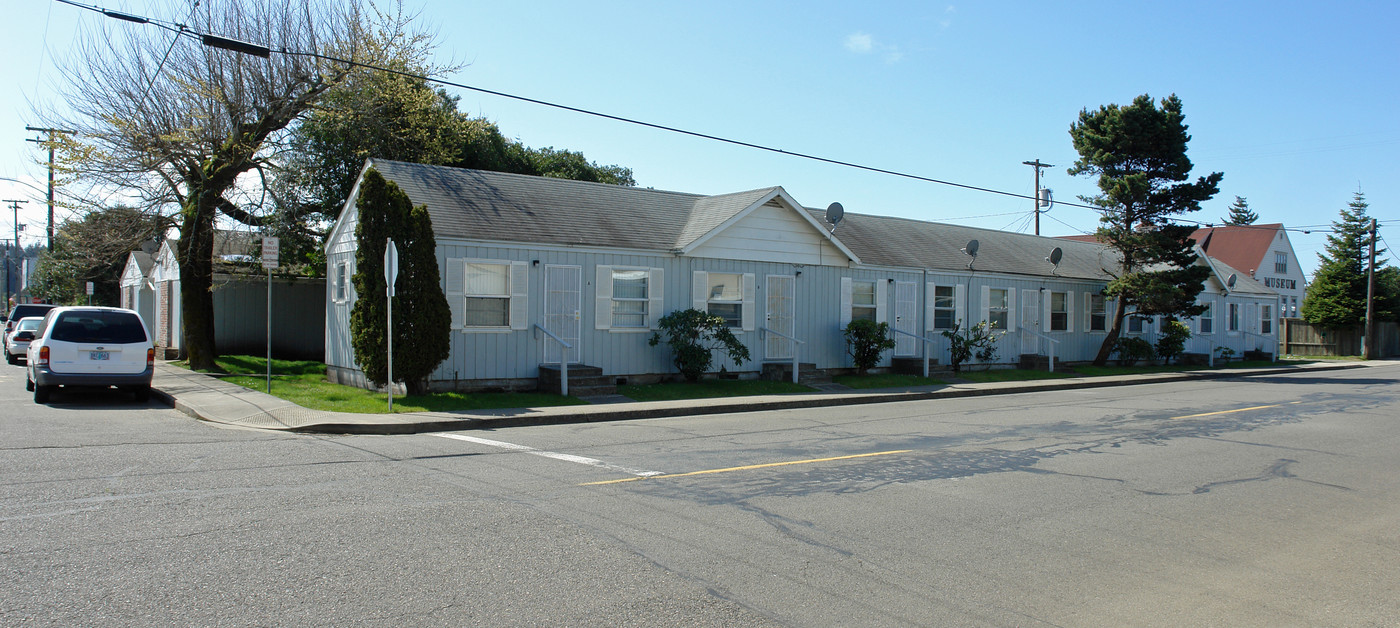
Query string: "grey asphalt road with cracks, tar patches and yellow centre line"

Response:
xmin=0 ymin=365 xmax=1400 ymax=627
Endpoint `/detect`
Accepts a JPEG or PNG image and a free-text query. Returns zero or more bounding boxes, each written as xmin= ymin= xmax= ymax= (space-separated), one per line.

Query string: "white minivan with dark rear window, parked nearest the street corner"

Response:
xmin=25 ymin=306 xmax=155 ymax=403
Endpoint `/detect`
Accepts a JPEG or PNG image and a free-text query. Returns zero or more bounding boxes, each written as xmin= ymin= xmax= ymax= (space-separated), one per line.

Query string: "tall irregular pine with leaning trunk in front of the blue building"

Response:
xmin=1070 ymin=94 xmax=1225 ymax=365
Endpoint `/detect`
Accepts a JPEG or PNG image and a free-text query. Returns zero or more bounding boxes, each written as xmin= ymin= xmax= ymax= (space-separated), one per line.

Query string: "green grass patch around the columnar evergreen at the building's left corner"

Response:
xmin=179 ymin=355 xmax=587 ymax=414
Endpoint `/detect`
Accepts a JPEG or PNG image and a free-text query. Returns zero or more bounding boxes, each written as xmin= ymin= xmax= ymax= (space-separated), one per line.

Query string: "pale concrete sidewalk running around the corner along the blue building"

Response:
xmin=151 ymin=362 xmax=1377 ymax=434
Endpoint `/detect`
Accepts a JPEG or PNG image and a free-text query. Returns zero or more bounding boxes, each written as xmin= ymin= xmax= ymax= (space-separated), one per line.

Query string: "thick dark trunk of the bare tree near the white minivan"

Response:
xmin=176 ymin=193 xmax=218 ymax=371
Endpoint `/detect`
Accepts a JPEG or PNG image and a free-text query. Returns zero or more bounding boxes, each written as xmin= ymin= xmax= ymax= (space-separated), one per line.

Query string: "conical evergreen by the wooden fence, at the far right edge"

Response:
xmin=1302 ymin=192 xmax=1400 ymax=327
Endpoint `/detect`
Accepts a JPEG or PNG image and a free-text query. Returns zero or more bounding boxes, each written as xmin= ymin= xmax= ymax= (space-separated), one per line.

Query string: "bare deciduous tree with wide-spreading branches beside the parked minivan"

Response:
xmin=46 ymin=0 xmax=416 ymax=368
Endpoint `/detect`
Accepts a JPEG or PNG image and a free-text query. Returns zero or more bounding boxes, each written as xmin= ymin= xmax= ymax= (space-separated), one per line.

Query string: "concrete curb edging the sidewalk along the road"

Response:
xmin=151 ymin=364 xmax=1364 ymax=435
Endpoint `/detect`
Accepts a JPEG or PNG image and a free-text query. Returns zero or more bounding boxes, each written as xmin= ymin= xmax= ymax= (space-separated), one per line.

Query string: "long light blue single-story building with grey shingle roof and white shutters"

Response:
xmin=325 ymin=159 xmax=1277 ymax=390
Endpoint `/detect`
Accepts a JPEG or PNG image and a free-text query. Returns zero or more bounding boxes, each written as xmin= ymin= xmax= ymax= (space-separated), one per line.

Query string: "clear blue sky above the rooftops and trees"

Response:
xmin=0 ymin=0 xmax=1400 ymax=271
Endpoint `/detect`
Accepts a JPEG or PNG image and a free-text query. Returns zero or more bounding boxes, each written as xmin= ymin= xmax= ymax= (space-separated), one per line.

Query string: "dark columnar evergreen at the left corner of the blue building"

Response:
xmin=350 ymin=168 xmax=452 ymax=394
